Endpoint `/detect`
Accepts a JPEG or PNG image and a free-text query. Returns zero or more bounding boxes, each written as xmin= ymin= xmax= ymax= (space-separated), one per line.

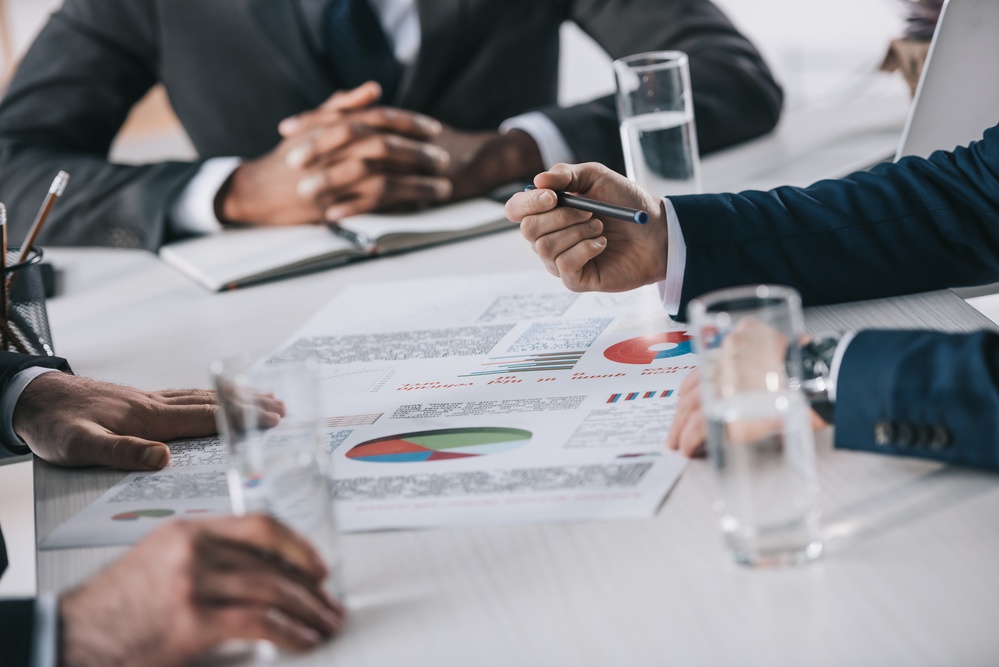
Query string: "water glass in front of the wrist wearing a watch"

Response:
xmin=690 ymin=285 xmax=822 ymax=566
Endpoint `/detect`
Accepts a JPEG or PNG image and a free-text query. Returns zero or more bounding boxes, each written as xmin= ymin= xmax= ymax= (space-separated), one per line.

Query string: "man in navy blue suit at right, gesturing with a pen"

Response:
xmin=507 ymin=122 xmax=999 ymax=468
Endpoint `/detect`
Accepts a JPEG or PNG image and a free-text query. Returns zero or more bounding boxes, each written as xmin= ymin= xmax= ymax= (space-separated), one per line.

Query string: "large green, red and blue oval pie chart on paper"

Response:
xmin=347 ymin=426 xmax=532 ymax=463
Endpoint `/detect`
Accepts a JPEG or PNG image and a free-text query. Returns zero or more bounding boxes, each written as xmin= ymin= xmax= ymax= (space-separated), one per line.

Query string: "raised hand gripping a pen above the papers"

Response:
xmin=506 ymin=163 xmax=667 ymax=292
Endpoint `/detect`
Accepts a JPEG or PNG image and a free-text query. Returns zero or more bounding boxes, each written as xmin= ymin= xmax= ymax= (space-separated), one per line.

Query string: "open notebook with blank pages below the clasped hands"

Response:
xmin=160 ymin=199 xmax=513 ymax=292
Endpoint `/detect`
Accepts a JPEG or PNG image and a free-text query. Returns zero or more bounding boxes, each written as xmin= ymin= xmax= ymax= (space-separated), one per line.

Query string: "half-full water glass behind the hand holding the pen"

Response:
xmin=614 ymin=51 xmax=701 ymax=196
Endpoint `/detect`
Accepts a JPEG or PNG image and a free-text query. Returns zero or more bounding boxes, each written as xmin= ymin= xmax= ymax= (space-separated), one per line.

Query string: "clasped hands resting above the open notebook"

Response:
xmin=222 ymin=82 xmax=542 ymax=225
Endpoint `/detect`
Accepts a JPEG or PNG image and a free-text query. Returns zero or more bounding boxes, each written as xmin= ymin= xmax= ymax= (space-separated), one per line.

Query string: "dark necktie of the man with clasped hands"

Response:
xmin=326 ymin=0 xmax=402 ymax=102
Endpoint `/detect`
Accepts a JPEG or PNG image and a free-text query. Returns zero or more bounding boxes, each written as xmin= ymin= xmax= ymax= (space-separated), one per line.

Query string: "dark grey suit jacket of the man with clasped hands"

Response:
xmin=0 ymin=0 xmax=781 ymax=249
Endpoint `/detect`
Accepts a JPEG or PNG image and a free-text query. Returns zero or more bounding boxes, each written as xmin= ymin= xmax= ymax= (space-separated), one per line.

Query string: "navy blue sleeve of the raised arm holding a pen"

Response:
xmin=670 ymin=122 xmax=999 ymax=315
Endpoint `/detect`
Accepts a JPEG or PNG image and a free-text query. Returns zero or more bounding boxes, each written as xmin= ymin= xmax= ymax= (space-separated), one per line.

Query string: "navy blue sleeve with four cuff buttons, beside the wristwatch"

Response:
xmin=835 ymin=331 xmax=999 ymax=469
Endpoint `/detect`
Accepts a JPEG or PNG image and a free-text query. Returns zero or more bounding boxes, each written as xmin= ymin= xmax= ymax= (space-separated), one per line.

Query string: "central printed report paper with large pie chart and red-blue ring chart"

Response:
xmin=268 ymin=272 xmax=696 ymax=531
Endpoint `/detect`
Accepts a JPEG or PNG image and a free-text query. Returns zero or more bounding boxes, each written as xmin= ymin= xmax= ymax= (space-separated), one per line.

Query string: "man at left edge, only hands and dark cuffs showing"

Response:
xmin=0 ymin=353 xmax=343 ymax=667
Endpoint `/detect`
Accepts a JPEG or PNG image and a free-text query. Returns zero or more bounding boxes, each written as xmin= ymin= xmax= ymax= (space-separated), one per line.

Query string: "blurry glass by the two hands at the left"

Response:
xmin=212 ymin=357 xmax=343 ymax=598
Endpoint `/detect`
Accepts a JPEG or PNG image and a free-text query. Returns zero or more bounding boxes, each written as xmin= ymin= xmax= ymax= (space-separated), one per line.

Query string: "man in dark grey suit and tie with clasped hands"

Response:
xmin=0 ymin=0 xmax=781 ymax=250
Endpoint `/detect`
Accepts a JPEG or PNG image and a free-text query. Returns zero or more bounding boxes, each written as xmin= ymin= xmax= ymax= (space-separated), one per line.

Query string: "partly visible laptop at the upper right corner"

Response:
xmin=895 ymin=0 xmax=999 ymax=160
